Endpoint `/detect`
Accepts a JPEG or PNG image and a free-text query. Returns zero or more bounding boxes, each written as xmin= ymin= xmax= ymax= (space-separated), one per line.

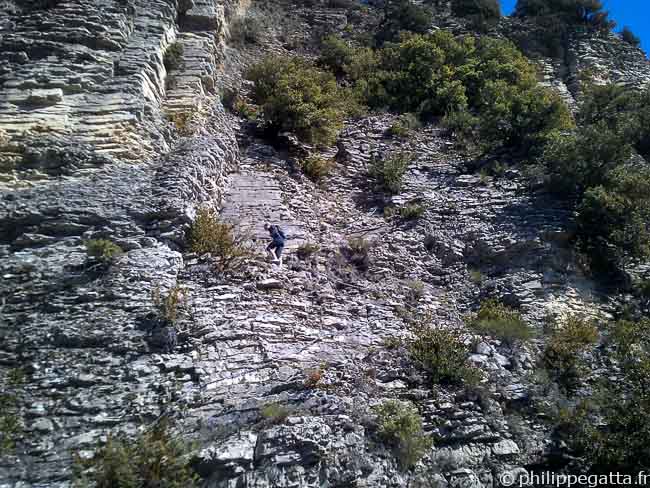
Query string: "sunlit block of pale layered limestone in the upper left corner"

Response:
xmin=0 ymin=0 xmax=233 ymax=185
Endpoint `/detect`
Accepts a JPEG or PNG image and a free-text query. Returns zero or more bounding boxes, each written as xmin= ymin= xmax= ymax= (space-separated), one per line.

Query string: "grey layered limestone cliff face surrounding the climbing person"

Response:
xmin=0 ymin=0 xmax=650 ymax=488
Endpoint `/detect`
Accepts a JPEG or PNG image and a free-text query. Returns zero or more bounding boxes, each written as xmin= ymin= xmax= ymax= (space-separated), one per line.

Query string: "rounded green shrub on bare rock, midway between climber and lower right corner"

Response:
xmin=408 ymin=322 xmax=480 ymax=384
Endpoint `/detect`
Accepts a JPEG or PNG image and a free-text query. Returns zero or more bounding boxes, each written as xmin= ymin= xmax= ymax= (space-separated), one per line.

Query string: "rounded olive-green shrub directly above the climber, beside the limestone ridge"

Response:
xmin=247 ymin=56 xmax=357 ymax=145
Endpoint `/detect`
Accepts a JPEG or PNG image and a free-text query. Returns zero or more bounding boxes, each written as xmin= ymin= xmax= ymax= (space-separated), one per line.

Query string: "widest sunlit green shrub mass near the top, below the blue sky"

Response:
xmin=358 ymin=30 xmax=573 ymax=150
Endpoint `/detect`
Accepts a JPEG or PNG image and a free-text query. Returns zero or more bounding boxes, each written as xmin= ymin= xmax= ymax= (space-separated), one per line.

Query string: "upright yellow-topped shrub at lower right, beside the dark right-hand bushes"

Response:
xmin=542 ymin=316 xmax=598 ymax=391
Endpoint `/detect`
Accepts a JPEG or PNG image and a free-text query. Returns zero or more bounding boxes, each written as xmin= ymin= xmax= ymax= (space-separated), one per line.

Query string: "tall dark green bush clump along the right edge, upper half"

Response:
xmin=541 ymin=82 xmax=650 ymax=276
